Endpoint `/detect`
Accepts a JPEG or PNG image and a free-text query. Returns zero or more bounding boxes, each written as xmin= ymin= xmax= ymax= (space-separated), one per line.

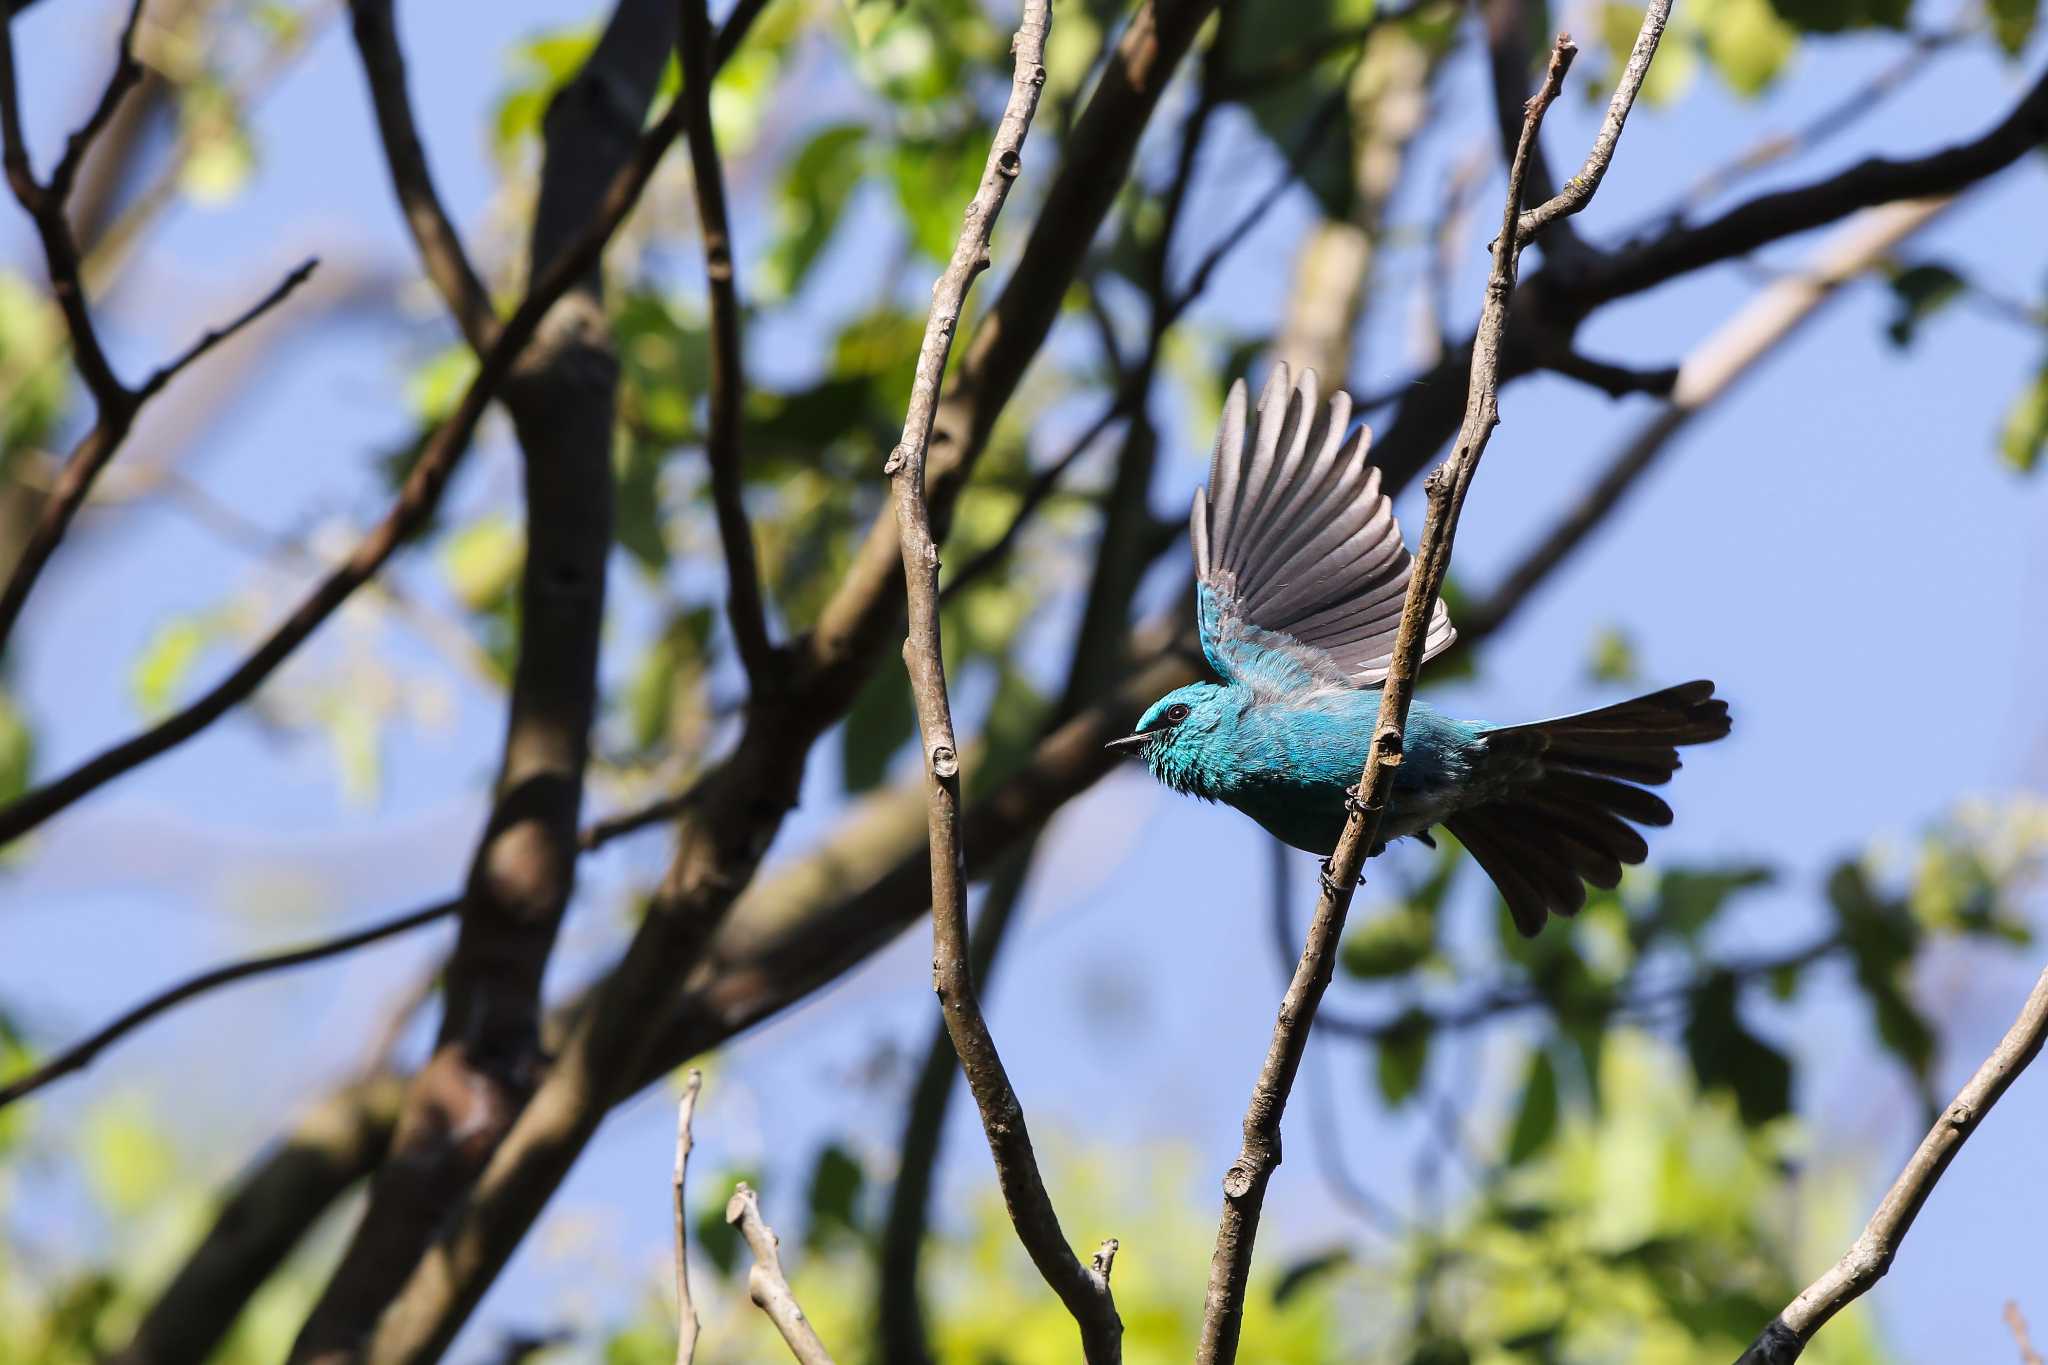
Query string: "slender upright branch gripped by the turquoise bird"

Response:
xmin=1196 ymin=13 xmax=1669 ymax=1365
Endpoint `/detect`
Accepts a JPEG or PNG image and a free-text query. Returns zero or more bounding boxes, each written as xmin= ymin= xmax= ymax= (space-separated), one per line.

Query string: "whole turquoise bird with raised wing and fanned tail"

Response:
xmin=1110 ymin=364 xmax=1729 ymax=935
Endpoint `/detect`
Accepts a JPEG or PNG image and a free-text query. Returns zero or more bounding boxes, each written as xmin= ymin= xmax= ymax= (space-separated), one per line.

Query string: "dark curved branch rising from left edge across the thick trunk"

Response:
xmin=0 ymin=5 xmax=682 ymax=847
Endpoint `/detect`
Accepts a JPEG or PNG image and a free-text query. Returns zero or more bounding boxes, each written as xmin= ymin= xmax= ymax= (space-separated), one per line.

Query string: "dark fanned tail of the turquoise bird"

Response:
xmin=1444 ymin=681 xmax=1729 ymax=935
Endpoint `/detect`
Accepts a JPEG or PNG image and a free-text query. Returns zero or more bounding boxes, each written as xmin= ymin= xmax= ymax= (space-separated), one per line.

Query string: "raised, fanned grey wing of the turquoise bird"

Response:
xmin=1190 ymin=364 xmax=1456 ymax=690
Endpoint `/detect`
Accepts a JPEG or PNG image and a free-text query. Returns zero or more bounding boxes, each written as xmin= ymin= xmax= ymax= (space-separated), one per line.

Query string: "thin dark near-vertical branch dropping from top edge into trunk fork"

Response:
xmin=680 ymin=0 xmax=784 ymax=690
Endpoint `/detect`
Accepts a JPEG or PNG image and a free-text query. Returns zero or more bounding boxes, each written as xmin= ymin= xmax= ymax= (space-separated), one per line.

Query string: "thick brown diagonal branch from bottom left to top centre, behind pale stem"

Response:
xmin=333 ymin=10 xmax=1214 ymax=1361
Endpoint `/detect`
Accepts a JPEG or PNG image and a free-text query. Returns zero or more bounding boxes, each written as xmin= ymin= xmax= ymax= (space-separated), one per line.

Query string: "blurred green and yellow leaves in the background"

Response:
xmin=0 ymin=0 xmax=2048 ymax=1365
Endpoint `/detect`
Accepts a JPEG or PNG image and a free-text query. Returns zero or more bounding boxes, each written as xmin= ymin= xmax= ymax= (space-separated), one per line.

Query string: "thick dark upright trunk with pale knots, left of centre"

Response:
xmin=295 ymin=0 xmax=688 ymax=1361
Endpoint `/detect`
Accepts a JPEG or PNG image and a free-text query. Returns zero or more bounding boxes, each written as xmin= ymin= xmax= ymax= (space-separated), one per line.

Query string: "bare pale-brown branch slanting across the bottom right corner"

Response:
xmin=1737 ymin=972 xmax=2048 ymax=1365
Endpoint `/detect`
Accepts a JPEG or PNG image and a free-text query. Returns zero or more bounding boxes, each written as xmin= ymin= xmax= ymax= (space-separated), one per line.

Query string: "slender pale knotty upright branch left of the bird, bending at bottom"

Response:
xmin=885 ymin=0 xmax=1122 ymax=1365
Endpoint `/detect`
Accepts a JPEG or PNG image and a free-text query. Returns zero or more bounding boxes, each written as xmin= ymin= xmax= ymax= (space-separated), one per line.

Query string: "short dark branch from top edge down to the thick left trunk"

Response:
xmin=348 ymin=0 xmax=498 ymax=356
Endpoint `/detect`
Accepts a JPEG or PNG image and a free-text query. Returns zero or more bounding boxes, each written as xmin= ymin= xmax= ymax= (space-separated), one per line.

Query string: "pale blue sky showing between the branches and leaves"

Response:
xmin=0 ymin=0 xmax=2048 ymax=1359
